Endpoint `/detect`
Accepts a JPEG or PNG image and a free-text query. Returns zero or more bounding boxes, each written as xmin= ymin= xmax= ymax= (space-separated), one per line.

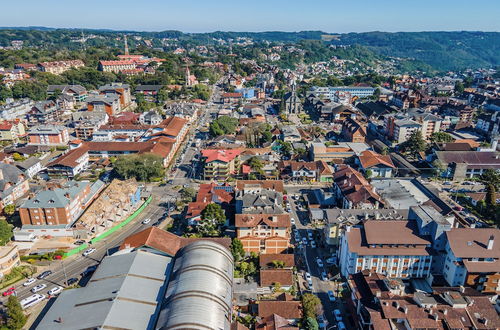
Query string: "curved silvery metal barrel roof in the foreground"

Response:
xmin=156 ymin=241 xmax=234 ymax=329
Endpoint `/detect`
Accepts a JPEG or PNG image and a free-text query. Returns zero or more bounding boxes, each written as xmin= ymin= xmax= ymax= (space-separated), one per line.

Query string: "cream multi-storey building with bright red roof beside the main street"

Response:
xmin=201 ymin=149 xmax=241 ymax=181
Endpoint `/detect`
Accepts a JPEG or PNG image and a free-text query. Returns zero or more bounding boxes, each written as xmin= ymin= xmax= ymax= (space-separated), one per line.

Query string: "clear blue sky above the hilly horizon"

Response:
xmin=0 ymin=0 xmax=500 ymax=33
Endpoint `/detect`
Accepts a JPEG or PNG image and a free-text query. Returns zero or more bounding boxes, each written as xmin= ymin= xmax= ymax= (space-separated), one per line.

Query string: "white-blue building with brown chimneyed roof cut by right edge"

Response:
xmin=443 ymin=228 xmax=500 ymax=294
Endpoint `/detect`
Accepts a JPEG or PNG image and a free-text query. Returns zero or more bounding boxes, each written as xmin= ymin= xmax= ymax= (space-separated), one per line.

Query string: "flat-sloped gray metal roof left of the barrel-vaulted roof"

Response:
xmin=37 ymin=250 xmax=172 ymax=330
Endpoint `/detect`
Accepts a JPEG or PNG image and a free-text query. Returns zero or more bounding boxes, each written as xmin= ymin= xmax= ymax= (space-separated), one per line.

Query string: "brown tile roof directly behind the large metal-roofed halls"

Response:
xmin=120 ymin=227 xmax=231 ymax=256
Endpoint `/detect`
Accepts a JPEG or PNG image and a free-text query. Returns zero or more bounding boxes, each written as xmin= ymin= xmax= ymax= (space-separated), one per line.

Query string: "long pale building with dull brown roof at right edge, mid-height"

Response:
xmin=435 ymin=151 xmax=500 ymax=181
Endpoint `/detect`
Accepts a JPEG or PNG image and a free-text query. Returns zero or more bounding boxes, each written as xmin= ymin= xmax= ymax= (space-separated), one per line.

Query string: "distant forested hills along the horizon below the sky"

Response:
xmin=0 ymin=27 xmax=500 ymax=72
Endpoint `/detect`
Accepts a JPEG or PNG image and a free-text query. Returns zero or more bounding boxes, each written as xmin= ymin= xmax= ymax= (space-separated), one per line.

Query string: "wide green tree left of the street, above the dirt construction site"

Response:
xmin=113 ymin=154 xmax=164 ymax=181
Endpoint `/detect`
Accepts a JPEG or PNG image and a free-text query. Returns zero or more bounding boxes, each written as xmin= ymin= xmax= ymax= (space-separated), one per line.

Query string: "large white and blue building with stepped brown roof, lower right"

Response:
xmin=339 ymin=220 xmax=432 ymax=278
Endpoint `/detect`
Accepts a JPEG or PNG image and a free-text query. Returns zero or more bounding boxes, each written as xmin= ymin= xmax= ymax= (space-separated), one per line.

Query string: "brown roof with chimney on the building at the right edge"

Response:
xmin=446 ymin=228 xmax=500 ymax=259
